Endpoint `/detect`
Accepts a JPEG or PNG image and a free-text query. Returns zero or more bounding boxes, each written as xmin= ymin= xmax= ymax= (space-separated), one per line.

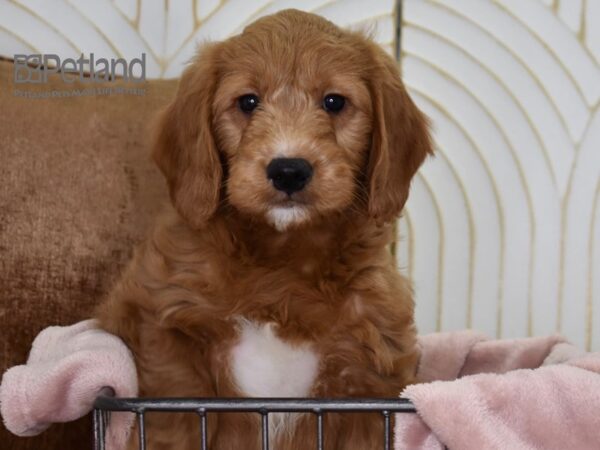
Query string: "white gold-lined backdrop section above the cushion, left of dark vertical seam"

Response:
xmin=0 ymin=0 xmax=396 ymax=78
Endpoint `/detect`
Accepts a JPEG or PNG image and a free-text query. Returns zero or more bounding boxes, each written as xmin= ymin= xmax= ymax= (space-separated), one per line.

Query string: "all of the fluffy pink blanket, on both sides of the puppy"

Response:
xmin=0 ymin=320 xmax=600 ymax=450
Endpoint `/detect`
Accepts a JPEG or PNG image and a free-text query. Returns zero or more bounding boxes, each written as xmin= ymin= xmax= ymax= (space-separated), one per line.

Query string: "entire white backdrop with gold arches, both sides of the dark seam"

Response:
xmin=0 ymin=0 xmax=600 ymax=350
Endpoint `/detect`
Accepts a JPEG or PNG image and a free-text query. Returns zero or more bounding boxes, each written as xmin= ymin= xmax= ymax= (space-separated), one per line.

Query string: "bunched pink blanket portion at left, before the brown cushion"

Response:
xmin=0 ymin=320 xmax=137 ymax=449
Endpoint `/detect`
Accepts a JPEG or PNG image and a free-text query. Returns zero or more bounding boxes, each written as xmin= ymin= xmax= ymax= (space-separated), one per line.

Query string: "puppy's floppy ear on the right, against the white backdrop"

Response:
xmin=367 ymin=44 xmax=433 ymax=222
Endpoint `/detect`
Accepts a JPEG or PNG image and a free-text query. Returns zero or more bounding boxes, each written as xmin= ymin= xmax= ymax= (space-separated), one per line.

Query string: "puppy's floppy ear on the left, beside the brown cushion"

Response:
xmin=153 ymin=44 xmax=223 ymax=228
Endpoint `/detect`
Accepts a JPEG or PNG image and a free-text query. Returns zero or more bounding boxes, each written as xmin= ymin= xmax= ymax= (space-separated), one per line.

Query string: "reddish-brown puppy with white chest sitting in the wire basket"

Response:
xmin=98 ymin=10 xmax=431 ymax=450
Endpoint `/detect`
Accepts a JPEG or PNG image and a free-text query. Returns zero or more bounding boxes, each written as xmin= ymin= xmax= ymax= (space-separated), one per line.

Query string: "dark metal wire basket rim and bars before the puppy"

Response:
xmin=93 ymin=396 xmax=416 ymax=450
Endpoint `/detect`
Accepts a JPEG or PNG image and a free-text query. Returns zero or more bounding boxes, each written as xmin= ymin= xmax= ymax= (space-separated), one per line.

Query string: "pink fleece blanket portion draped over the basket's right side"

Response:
xmin=395 ymin=331 xmax=600 ymax=450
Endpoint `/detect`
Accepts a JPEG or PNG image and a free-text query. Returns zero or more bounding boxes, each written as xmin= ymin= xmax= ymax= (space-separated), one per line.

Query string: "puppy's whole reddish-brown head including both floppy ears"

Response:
xmin=154 ymin=10 xmax=431 ymax=231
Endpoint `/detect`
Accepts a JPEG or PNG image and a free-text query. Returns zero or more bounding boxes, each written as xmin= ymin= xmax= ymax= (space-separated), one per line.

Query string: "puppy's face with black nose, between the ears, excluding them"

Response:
xmin=213 ymin=26 xmax=372 ymax=230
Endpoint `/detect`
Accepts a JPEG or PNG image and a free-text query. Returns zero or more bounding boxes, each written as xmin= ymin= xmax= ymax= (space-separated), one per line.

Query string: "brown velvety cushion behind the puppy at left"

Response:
xmin=0 ymin=61 xmax=176 ymax=450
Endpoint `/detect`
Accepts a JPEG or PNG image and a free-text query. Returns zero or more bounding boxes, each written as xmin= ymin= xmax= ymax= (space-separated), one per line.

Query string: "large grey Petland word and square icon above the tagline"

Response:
xmin=14 ymin=53 xmax=146 ymax=84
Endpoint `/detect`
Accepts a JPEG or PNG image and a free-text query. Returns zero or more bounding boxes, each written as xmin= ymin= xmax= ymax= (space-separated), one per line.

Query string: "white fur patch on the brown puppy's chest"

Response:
xmin=231 ymin=320 xmax=319 ymax=397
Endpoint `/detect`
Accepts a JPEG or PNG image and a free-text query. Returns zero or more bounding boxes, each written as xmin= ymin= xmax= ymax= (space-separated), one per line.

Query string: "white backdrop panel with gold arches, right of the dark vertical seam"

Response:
xmin=398 ymin=0 xmax=600 ymax=349
